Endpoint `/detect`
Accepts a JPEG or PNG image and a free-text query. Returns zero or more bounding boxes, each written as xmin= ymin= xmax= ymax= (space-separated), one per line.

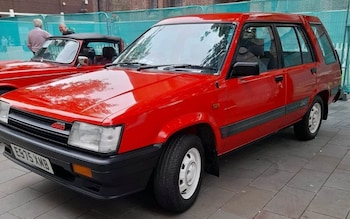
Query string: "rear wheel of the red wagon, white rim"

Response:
xmin=294 ymin=96 xmax=324 ymax=140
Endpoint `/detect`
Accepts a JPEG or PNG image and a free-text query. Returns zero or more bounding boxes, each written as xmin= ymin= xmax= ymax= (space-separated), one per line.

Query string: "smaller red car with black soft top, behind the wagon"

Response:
xmin=0 ymin=33 xmax=124 ymax=94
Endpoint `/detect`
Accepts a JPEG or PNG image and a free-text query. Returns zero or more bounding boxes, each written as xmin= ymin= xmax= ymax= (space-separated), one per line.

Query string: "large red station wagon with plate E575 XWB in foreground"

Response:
xmin=0 ymin=13 xmax=341 ymax=212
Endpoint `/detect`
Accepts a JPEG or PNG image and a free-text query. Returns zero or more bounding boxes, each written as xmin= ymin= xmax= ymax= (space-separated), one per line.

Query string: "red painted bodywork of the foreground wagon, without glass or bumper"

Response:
xmin=1 ymin=13 xmax=341 ymax=155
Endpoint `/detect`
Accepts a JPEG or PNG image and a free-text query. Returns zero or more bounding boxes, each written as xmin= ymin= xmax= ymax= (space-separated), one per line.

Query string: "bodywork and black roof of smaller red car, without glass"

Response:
xmin=0 ymin=34 xmax=124 ymax=94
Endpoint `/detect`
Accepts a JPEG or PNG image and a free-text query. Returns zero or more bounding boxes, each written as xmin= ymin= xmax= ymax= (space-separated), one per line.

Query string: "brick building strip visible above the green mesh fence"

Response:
xmin=0 ymin=0 xmax=242 ymax=15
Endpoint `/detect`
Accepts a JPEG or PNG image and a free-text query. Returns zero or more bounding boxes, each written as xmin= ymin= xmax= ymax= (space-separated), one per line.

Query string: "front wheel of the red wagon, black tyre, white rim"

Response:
xmin=153 ymin=135 xmax=204 ymax=212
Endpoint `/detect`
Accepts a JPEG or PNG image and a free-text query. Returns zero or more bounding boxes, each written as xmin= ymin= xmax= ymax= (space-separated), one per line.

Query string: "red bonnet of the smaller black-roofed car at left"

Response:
xmin=0 ymin=60 xmax=57 ymax=72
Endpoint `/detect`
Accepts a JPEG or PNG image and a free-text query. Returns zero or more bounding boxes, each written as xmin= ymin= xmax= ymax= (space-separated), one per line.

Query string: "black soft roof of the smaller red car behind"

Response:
xmin=48 ymin=33 xmax=122 ymax=43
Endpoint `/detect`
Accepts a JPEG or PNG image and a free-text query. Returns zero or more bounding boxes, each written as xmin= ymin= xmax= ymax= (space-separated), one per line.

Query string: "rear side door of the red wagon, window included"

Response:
xmin=276 ymin=24 xmax=318 ymax=124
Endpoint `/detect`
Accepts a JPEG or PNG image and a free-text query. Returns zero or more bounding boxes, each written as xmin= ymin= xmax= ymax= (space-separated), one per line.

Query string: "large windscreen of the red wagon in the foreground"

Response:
xmin=113 ymin=23 xmax=234 ymax=74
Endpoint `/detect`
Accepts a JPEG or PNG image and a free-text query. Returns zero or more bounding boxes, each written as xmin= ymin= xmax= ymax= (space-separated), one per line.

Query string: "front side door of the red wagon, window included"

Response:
xmin=221 ymin=23 xmax=286 ymax=152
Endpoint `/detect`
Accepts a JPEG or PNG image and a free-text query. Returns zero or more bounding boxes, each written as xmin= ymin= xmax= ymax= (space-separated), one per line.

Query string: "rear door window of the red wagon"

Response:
xmin=276 ymin=26 xmax=314 ymax=67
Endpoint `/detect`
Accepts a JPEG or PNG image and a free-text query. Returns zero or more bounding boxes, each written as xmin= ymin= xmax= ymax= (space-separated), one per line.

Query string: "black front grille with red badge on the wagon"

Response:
xmin=8 ymin=108 xmax=72 ymax=146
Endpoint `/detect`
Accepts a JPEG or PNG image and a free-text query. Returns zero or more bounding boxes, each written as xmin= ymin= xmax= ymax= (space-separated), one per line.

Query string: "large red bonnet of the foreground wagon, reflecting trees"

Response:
xmin=4 ymin=69 xmax=208 ymax=123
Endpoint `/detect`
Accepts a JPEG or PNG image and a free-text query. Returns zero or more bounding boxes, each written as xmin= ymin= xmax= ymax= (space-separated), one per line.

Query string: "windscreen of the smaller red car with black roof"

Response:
xmin=32 ymin=39 xmax=79 ymax=64
